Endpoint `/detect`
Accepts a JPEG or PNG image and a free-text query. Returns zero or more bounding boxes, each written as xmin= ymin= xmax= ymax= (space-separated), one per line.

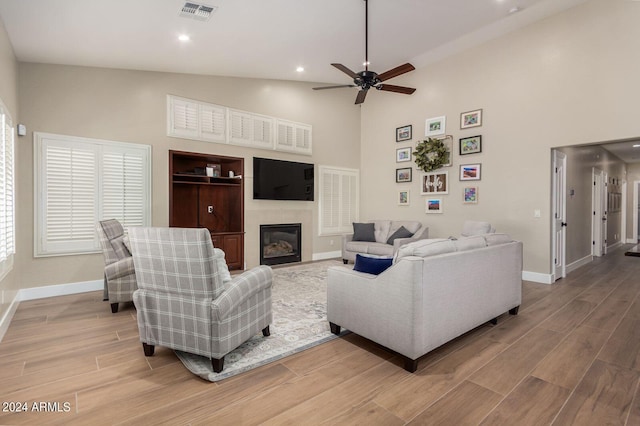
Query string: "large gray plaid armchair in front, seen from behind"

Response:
xmin=129 ymin=228 xmax=272 ymax=373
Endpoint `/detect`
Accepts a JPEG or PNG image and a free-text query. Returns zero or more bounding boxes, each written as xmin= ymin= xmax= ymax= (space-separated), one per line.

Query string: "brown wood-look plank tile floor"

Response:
xmin=0 ymin=246 xmax=640 ymax=425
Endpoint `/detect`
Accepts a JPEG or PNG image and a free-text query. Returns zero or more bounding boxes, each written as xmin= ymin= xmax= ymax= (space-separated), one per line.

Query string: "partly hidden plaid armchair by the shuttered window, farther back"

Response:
xmin=98 ymin=219 xmax=137 ymax=314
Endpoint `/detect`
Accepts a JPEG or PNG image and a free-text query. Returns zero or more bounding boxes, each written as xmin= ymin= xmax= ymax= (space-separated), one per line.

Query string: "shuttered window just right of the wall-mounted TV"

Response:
xmin=318 ymin=166 xmax=360 ymax=236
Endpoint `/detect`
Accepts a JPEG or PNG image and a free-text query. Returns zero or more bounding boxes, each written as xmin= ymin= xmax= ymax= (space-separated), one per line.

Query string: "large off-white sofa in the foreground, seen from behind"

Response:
xmin=327 ymin=234 xmax=522 ymax=372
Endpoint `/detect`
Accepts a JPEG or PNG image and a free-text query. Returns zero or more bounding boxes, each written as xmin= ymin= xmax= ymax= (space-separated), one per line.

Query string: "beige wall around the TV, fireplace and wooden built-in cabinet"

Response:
xmin=18 ymin=63 xmax=360 ymax=287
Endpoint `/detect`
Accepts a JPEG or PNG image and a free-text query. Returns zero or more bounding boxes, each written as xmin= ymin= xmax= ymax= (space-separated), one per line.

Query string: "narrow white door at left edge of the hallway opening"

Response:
xmin=551 ymin=149 xmax=567 ymax=282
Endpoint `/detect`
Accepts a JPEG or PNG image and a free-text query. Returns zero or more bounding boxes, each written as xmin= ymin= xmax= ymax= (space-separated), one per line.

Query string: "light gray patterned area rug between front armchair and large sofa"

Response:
xmin=175 ymin=260 xmax=347 ymax=382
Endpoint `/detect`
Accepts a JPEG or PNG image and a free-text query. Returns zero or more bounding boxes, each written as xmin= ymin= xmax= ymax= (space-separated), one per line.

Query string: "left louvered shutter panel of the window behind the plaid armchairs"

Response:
xmin=41 ymin=141 xmax=98 ymax=253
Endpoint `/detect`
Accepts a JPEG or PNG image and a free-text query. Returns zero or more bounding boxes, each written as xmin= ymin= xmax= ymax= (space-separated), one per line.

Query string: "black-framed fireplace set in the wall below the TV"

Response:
xmin=260 ymin=223 xmax=302 ymax=265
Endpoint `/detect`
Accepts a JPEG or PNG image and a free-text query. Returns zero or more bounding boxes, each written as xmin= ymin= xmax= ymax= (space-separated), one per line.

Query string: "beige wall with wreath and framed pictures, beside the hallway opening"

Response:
xmin=361 ymin=0 xmax=640 ymax=274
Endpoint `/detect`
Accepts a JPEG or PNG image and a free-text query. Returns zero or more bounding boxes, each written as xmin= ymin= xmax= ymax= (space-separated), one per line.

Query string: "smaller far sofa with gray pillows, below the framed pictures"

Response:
xmin=342 ymin=220 xmax=429 ymax=264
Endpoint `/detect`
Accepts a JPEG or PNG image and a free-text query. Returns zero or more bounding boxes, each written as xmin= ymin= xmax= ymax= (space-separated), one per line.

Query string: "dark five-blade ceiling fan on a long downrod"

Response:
xmin=313 ymin=0 xmax=416 ymax=105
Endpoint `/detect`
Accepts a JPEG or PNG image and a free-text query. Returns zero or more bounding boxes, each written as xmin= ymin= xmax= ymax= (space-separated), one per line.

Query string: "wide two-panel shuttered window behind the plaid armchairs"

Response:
xmin=34 ymin=133 xmax=151 ymax=256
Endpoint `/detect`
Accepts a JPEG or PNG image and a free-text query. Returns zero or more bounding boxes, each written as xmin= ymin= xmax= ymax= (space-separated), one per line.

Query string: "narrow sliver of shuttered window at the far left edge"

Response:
xmin=0 ymin=101 xmax=16 ymax=280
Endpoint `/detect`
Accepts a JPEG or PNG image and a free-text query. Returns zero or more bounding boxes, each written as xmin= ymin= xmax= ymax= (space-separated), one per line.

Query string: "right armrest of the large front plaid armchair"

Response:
xmin=211 ymin=265 xmax=273 ymax=321
